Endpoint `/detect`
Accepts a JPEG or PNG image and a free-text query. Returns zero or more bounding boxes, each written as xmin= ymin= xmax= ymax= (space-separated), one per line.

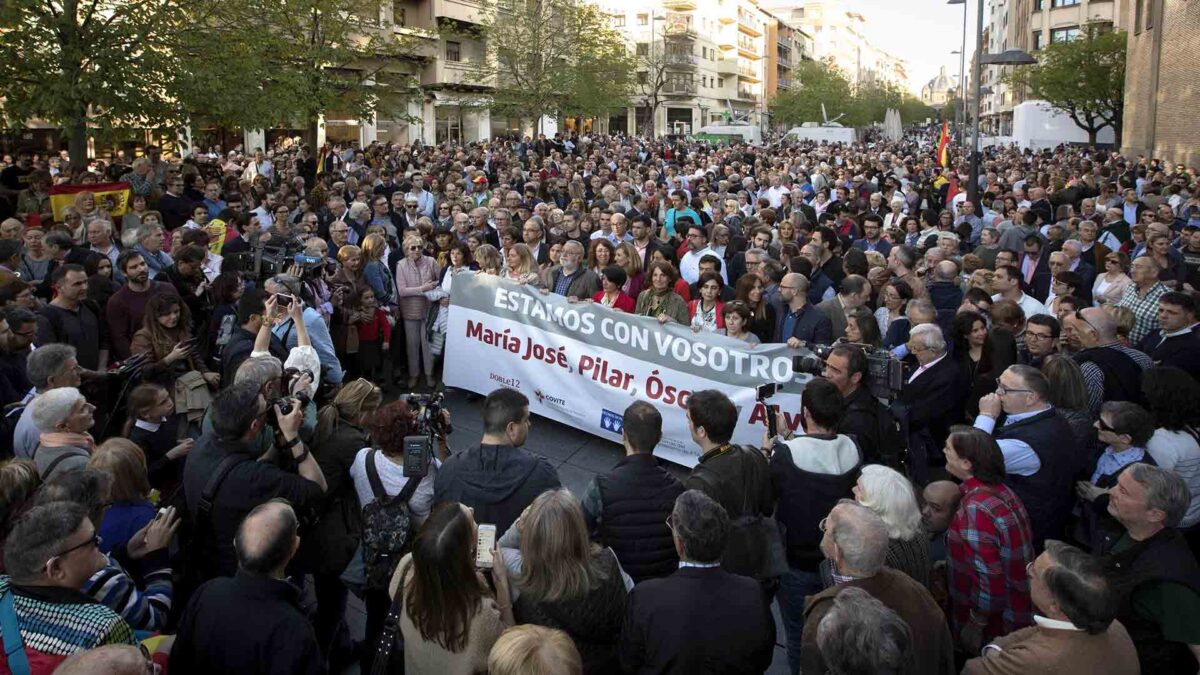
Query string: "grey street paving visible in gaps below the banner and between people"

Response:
xmin=333 ymin=390 xmax=787 ymax=675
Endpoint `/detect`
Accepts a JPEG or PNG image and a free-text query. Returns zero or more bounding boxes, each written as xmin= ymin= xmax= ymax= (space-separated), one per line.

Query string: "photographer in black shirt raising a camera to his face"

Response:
xmin=184 ymin=382 xmax=326 ymax=581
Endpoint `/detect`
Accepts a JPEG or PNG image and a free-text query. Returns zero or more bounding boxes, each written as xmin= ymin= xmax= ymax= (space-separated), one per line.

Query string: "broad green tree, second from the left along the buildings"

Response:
xmin=176 ymin=0 xmax=424 ymax=143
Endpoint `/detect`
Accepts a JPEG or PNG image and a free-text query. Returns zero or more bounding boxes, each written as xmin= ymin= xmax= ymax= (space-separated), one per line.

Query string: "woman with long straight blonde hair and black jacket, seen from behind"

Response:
xmin=498 ymin=489 xmax=634 ymax=673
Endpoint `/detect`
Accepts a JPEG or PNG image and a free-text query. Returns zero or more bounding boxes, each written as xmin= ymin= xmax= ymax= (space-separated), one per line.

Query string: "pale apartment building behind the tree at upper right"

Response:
xmin=979 ymin=0 xmax=1123 ymax=136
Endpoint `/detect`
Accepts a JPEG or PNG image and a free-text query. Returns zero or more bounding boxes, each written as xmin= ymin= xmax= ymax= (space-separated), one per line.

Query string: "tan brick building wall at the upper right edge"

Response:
xmin=1121 ymin=0 xmax=1200 ymax=167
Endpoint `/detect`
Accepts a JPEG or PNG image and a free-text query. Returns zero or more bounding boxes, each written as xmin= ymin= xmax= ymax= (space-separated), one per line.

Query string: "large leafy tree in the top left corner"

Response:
xmin=0 ymin=0 xmax=184 ymax=163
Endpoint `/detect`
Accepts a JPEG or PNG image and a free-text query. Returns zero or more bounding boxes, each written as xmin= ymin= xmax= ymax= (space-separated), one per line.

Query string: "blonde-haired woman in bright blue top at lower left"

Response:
xmin=88 ymin=438 xmax=158 ymax=552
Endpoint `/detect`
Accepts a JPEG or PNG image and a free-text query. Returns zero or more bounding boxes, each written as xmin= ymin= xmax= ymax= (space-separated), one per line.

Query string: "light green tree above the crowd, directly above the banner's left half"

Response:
xmin=478 ymin=0 xmax=634 ymax=133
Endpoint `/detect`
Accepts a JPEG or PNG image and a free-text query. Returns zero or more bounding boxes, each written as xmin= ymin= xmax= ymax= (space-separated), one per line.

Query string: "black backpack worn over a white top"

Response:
xmin=362 ymin=449 xmax=421 ymax=591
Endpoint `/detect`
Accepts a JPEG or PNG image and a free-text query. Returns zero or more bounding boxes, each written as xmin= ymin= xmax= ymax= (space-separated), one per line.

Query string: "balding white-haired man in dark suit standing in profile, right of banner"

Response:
xmin=895 ymin=323 xmax=967 ymax=484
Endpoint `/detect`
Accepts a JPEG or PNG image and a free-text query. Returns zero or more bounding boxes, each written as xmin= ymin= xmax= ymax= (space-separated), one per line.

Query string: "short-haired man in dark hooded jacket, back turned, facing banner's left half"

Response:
xmin=433 ymin=388 xmax=562 ymax=532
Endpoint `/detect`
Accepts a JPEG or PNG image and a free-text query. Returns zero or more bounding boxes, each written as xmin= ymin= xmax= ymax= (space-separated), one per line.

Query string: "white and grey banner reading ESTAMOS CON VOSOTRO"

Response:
xmin=443 ymin=274 xmax=810 ymax=466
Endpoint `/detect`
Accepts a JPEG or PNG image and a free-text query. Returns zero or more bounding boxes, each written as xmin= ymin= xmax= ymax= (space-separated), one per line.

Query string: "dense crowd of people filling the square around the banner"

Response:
xmin=0 ymin=129 xmax=1200 ymax=675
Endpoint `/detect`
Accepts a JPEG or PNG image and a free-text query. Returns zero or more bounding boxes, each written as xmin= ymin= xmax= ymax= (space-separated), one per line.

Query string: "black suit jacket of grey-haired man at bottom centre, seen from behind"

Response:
xmin=619 ymin=567 xmax=775 ymax=675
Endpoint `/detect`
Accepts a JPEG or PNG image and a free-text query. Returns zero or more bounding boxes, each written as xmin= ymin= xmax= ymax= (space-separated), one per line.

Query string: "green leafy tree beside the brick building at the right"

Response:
xmin=1006 ymin=26 xmax=1126 ymax=144
